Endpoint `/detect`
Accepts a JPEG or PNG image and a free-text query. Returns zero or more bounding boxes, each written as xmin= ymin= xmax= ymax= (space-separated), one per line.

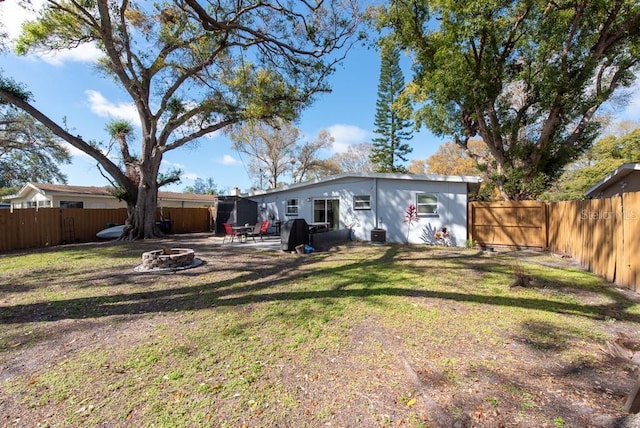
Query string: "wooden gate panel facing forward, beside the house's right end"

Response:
xmin=468 ymin=201 xmax=547 ymax=248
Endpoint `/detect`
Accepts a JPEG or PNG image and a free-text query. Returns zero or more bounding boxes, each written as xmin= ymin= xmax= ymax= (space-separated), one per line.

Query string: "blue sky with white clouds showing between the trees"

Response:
xmin=0 ymin=0 xmax=640 ymax=191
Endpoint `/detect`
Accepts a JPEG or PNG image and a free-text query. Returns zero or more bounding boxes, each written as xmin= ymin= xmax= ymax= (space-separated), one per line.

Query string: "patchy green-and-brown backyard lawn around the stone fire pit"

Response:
xmin=0 ymin=235 xmax=640 ymax=427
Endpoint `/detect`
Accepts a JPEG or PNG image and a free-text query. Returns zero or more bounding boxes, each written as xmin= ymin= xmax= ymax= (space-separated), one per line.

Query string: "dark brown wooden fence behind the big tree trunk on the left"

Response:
xmin=0 ymin=208 xmax=215 ymax=251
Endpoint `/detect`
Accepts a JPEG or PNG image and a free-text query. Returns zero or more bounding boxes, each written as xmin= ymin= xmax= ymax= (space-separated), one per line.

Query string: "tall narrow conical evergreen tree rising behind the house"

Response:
xmin=370 ymin=45 xmax=413 ymax=172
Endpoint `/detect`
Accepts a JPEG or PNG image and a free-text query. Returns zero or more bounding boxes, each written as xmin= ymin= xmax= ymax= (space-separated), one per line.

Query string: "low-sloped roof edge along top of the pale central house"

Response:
xmin=248 ymin=173 xmax=482 ymax=197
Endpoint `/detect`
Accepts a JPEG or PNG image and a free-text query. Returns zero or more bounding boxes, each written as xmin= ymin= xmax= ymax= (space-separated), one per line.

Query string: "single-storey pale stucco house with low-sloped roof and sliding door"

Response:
xmin=243 ymin=173 xmax=481 ymax=246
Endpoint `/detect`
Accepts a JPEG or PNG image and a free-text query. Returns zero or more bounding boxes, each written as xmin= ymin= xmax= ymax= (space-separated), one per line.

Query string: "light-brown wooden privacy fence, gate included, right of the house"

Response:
xmin=468 ymin=196 xmax=640 ymax=291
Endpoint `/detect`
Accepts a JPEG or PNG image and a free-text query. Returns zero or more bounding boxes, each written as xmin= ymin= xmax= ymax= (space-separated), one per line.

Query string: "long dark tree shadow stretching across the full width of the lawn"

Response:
xmin=0 ymin=247 xmax=640 ymax=324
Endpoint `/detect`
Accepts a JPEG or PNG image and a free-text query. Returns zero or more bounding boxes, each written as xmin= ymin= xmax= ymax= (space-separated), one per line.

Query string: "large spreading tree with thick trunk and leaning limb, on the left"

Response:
xmin=0 ymin=0 xmax=360 ymax=239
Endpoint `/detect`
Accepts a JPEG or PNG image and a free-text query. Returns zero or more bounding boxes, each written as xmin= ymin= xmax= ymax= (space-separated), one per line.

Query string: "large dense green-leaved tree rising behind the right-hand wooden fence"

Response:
xmin=379 ymin=0 xmax=640 ymax=199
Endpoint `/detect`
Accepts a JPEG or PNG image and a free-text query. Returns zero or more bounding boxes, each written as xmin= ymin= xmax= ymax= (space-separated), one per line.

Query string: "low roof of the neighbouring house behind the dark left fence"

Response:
xmin=7 ymin=183 xmax=217 ymax=202
